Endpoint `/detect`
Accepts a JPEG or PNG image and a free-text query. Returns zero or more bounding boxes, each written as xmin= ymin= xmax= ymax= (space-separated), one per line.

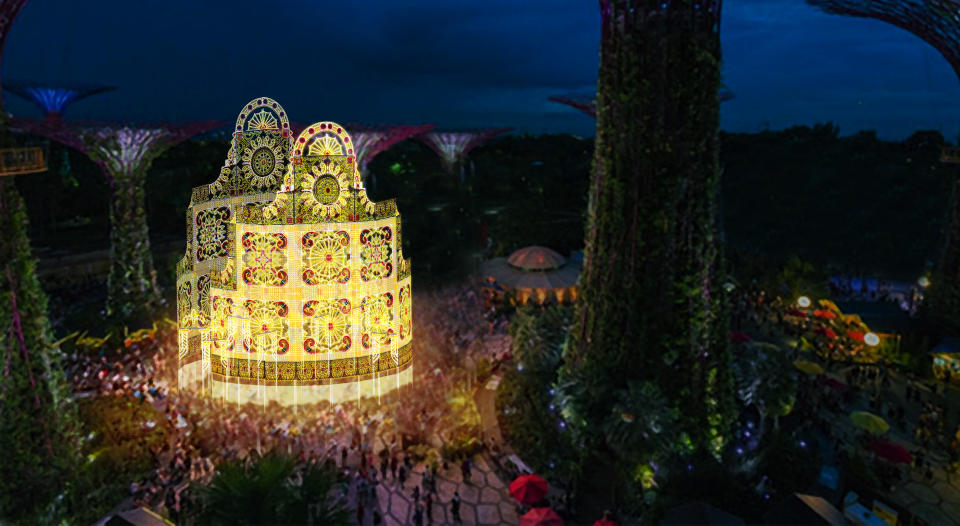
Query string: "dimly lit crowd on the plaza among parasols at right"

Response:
xmin=733 ymin=286 xmax=960 ymax=516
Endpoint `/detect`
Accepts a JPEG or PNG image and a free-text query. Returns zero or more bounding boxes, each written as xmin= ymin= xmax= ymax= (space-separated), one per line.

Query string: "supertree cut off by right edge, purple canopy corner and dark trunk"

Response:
xmin=807 ymin=0 xmax=960 ymax=334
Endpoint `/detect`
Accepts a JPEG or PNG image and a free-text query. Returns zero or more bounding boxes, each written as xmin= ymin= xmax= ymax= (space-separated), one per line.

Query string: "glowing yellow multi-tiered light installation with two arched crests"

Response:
xmin=177 ymin=97 xmax=413 ymax=405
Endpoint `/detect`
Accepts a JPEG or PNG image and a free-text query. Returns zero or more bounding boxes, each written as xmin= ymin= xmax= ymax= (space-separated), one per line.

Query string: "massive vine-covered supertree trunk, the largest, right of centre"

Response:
xmin=562 ymin=0 xmax=733 ymax=468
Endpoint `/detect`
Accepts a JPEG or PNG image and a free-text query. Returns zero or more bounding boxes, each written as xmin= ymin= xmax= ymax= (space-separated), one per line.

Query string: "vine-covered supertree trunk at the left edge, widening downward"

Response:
xmin=0 ymin=174 xmax=77 ymax=523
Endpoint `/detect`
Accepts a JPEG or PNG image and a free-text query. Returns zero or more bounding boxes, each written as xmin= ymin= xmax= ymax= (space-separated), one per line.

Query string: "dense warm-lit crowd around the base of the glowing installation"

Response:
xmin=66 ymin=286 xmax=509 ymax=523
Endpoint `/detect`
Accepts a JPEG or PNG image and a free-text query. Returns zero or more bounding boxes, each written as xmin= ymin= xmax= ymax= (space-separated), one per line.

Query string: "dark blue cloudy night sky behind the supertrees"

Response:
xmin=3 ymin=0 xmax=960 ymax=140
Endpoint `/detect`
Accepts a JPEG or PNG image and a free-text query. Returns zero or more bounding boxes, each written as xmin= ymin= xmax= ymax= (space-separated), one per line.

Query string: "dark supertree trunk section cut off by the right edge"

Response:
xmin=923 ymin=177 xmax=960 ymax=336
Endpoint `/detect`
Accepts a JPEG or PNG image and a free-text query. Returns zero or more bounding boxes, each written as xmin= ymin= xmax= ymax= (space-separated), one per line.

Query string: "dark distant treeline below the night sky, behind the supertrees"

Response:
xmin=17 ymin=124 xmax=958 ymax=281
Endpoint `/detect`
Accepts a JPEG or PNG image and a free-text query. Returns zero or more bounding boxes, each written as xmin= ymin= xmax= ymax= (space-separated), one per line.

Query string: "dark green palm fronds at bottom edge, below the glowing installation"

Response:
xmin=199 ymin=452 xmax=350 ymax=525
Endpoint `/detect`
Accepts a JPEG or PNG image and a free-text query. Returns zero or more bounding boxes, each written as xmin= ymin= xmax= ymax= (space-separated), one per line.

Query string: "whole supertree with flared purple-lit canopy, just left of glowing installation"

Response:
xmin=13 ymin=119 xmax=223 ymax=321
